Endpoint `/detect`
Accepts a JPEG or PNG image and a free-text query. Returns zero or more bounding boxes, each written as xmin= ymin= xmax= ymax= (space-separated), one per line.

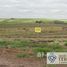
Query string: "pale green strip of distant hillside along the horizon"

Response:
xmin=0 ymin=18 xmax=67 ymax=24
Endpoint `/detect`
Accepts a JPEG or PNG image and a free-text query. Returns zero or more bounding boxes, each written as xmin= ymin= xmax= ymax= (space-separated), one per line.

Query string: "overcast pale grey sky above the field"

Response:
xmin=0 ymin=0 xmax=67 ymax=19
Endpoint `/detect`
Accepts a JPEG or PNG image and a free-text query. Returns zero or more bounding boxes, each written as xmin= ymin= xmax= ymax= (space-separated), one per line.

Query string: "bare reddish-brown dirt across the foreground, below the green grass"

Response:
xmin=0 ymin=48 xmax=67 ymax=67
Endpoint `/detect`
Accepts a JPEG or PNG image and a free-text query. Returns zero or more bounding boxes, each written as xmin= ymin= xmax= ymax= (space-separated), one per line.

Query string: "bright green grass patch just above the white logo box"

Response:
xmin=34 ymin=44 xmax=64 ymax=54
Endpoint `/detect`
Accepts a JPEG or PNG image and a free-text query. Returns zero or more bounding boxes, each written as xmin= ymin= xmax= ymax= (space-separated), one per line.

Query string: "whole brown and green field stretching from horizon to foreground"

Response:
xmin=0 ymin=18 xmax=67 ymax=67
